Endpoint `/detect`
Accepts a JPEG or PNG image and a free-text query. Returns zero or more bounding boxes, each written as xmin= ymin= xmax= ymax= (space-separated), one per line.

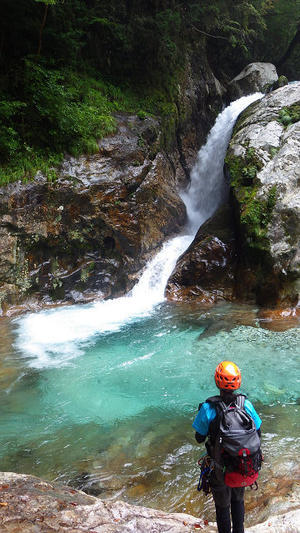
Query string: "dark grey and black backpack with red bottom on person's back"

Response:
xmin=206 ymin=394 xmax=262 ymax=487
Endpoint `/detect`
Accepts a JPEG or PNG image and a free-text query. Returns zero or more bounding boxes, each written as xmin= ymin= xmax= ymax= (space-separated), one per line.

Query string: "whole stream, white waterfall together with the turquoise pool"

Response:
xmin=0 ymin=94 xmax=300 ymax=522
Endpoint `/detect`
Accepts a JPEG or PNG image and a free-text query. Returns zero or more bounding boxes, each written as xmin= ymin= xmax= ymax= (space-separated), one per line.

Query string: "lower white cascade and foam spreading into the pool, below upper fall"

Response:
xmin=16 ymin=235 xmax=192 ymax=368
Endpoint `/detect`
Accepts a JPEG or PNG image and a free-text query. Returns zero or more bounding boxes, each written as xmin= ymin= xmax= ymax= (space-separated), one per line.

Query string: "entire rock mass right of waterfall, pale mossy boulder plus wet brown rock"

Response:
xmin=166 ymin=82 xmax=300 ymax=314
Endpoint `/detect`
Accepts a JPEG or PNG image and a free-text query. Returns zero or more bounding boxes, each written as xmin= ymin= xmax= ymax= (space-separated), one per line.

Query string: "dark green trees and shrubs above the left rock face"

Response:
xmin=0 ymin=0 xmax=299 ymax=184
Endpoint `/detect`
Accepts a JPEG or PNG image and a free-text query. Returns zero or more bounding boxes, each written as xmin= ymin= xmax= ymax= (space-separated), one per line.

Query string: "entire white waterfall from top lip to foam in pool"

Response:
xmin=16 ymin=93 xmax=262 ymax=368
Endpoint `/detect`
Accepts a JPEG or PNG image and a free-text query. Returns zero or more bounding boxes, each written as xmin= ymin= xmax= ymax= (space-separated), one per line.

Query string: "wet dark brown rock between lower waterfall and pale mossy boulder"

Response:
xmin=166 ymin=205 xmax=236 ymax=303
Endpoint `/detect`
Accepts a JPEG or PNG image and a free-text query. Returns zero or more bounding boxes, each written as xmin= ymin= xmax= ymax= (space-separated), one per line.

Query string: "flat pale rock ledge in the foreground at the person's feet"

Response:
xmin=0 ymin=472 xmax=300 ymax=533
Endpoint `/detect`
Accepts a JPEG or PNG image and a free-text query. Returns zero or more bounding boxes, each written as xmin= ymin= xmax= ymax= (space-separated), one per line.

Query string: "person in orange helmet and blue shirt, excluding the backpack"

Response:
xmin=193 ymin=361 xmax=261 ymax=533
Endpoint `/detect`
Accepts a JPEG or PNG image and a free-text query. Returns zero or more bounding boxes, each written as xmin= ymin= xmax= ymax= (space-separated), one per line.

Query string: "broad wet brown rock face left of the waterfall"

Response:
xmin=0 ymin=115 xmax=186 ymax=311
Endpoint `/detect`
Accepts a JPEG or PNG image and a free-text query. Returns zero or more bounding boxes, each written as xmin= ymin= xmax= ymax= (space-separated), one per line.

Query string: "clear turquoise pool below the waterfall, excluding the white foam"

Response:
xmin=0 ymin=303 xmax=300 ymax=513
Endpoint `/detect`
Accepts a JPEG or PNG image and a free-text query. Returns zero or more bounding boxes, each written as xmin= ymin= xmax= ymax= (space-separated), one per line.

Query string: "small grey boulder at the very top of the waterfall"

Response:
xmin=229 ymin=62 xmax=278 ymax=100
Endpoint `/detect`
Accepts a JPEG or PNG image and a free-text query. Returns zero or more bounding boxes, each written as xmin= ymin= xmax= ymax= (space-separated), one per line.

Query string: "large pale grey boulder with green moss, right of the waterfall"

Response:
xmin=226 ymin=82 xmax=300 ymax=307
